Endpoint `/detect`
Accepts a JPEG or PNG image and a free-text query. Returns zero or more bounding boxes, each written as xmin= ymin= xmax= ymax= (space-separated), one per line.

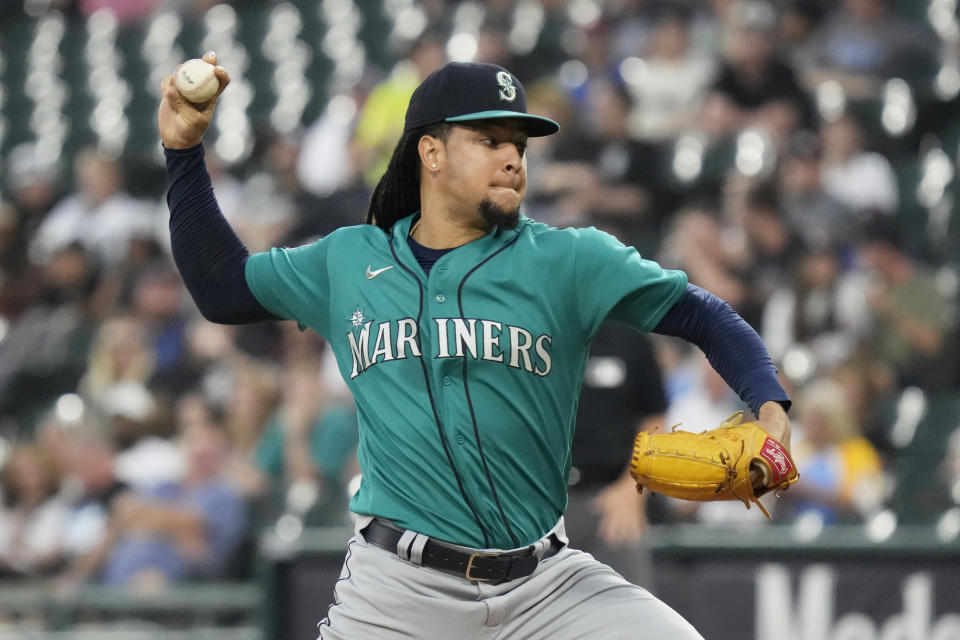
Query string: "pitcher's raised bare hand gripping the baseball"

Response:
xmin=157 ymin=51 xmax=230 ymax=149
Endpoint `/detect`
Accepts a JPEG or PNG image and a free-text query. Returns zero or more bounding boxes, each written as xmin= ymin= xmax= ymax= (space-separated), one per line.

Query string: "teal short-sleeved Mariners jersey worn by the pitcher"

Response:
xmin=246 ymin=216 xmax=687 ymax=549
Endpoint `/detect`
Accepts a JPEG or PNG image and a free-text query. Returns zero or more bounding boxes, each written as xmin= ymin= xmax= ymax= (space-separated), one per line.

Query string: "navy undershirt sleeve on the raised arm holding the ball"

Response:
xmin=164 ymin=145 xmax=279 ymax=324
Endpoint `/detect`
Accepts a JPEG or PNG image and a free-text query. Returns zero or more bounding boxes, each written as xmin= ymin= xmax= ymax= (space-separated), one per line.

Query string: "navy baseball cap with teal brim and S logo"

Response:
xmin=403 ymin=62 xmax=560 ymax=137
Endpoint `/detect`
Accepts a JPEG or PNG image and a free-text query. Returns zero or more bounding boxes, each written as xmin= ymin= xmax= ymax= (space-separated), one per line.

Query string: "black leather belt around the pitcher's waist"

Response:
xmin=360 ymin=519 xmax=563 ymax=583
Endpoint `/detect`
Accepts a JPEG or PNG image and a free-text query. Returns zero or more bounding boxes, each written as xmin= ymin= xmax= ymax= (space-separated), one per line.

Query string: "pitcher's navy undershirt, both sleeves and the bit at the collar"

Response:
xmin=164 ymin=145 xmax=790 ymax=413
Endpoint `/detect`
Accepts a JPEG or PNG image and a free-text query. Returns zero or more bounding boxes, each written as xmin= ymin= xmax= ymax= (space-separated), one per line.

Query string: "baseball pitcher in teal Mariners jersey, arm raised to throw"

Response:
xmin=159 ymin=53 xmax=796 ymax=640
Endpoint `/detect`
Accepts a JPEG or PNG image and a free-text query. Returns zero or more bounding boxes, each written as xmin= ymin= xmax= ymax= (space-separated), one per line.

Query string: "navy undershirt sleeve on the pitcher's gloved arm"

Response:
xmin=653 ymin=284 xmax=791 ymax=415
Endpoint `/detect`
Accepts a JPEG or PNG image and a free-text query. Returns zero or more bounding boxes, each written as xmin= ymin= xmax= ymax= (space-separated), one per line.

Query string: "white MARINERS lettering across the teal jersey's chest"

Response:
xmin=346 ymin=315 xmax=553 ymax=378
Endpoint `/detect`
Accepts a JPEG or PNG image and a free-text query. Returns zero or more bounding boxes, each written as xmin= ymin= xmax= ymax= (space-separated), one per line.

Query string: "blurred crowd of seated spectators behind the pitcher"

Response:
xmin=0 ymin=0 xmax=960 ymax=589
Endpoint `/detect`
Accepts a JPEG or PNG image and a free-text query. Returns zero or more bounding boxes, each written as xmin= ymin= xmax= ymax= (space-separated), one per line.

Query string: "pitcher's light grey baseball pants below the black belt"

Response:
xmin=318 ymin=517 xmax=703 ymax=640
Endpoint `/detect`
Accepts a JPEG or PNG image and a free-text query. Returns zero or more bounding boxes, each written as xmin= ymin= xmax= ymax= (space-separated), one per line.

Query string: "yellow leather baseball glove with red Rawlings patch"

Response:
xmin=630 ymin=411 xmax=799 ymax=518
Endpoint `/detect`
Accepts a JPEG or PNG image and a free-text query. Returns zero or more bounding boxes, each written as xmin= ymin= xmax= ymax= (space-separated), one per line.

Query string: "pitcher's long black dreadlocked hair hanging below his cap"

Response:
xmin=365 ymin=122 xmax=450 ymax=231
